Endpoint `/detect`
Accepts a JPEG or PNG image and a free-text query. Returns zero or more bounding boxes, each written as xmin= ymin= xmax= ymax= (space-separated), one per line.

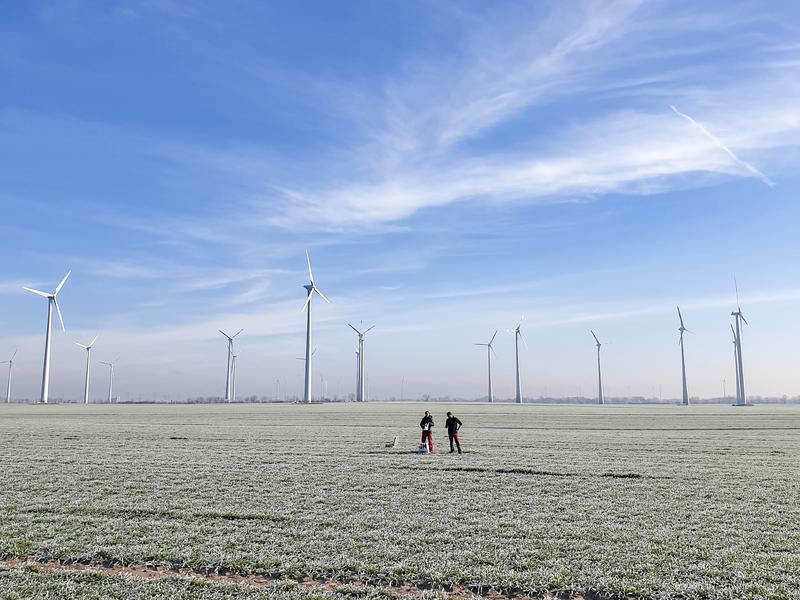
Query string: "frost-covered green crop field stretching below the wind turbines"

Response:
xmin=0 ymin=404 xmax=800 ymax=599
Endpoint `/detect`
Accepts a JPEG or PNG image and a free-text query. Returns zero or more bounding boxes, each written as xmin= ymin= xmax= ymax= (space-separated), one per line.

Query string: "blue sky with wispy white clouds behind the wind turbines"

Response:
xmin=0 ymin=0 xmax=800 ymax=400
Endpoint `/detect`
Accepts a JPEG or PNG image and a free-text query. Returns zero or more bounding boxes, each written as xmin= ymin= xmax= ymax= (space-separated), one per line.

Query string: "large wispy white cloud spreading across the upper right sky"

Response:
xmin=260 ymin=2 xmax=800 ymax=229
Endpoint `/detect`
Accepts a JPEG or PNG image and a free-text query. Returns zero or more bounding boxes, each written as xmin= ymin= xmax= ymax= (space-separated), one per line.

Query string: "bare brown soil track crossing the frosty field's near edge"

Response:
xmin=0 ymin=556 xmax=634 ymax=600
